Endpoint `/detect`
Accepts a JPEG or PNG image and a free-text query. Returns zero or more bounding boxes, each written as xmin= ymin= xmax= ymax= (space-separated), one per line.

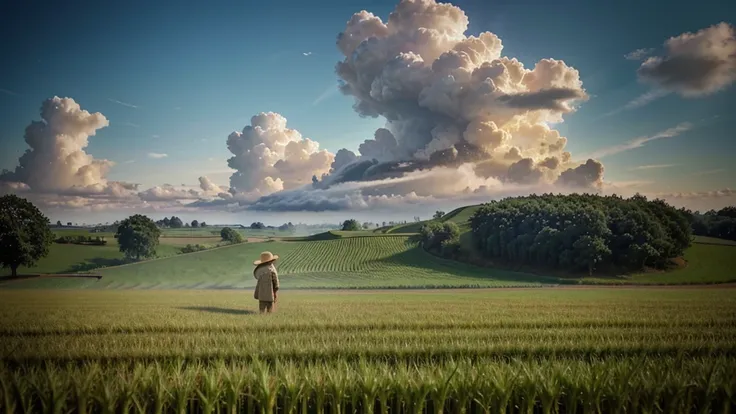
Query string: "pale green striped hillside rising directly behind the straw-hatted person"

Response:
xmin=2 ymin=232 xmax=555 ymax=289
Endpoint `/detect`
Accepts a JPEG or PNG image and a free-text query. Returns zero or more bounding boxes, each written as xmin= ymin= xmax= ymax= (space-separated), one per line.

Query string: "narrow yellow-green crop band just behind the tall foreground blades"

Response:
xmin=5 ymin=330 xmax=736 ymax=361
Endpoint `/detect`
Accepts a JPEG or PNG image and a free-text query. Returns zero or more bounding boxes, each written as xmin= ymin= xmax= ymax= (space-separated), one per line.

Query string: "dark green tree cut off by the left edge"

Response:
xmin=0 ymin=194 xmax=54 ymax=276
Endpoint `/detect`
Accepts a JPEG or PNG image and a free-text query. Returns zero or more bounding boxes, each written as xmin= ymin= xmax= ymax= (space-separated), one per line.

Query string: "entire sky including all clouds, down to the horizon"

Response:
xmin=0 ymin=0 xmax=736 ymax=224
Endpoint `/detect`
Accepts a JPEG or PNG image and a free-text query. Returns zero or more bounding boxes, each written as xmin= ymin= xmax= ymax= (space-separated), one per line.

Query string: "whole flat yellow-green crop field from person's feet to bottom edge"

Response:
xmin=0 ymin=288 xmax=736 ymax=414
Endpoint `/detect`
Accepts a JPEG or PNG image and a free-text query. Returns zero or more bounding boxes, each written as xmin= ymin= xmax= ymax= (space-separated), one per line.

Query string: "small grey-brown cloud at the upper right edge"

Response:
xmin=638 ymin=22 xmax=736 ymax=97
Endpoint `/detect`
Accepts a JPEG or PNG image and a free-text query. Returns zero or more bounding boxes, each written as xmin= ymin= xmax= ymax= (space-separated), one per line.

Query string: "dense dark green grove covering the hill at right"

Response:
xmin=470 ymin=194 xmax=692 ymax=274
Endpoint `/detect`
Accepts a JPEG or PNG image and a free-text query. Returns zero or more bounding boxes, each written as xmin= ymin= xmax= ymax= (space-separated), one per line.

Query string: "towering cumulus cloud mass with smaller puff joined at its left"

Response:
xmin=221 ymin=0 xmax=603 ymax=210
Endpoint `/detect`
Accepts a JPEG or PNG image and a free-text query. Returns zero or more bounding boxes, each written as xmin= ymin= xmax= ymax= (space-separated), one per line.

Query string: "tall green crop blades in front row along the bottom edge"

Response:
xmin=0 ymin=358 xmax=736 ymax=414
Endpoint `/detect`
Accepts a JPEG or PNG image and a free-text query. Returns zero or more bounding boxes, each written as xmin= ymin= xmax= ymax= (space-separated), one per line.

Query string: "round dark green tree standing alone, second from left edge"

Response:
xmin=115 ymin=214 xmax=161 ymax=260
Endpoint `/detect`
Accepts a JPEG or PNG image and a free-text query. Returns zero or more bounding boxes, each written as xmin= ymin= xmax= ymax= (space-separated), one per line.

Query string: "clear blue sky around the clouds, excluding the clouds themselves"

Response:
xmin=0 ymin=0 xmax=736 ymax=222
